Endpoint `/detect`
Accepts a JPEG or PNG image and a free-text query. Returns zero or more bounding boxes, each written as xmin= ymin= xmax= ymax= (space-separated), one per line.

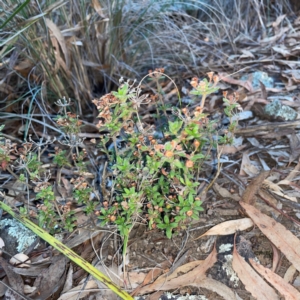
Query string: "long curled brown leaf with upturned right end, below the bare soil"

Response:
xmin=139 ymin=247 xmax=217 ymax=295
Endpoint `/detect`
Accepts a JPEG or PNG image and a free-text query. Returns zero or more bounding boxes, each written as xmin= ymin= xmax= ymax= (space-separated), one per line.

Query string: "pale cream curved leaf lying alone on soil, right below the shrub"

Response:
xmin=195 ymin=218 xmax=254 ymax=240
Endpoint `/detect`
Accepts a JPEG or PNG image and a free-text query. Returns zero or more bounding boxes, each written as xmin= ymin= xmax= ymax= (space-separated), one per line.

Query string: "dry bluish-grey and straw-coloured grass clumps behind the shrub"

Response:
xmin=0 ymin=0 xmax=290 ymax=119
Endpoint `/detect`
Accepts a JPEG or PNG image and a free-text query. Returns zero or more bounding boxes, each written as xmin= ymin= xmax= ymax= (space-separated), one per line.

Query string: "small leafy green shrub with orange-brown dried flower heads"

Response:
xmin=93 ymin=70 xmax=237 ymax=238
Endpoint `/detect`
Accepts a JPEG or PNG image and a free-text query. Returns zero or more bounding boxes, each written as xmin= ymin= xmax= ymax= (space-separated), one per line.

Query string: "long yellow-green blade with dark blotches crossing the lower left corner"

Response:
xmin=0 ymin=201 xmax=133 ymax=300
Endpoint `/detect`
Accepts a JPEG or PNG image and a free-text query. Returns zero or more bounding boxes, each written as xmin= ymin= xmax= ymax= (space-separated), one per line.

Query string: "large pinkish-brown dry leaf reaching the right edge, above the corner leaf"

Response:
xmin=240 ymin=201 xmax=300 ymax=271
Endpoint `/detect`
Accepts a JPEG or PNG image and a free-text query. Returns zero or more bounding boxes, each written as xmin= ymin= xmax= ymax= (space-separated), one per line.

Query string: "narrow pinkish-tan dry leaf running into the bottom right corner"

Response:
xmin=249 ymin=258 xmax=300 ymax=300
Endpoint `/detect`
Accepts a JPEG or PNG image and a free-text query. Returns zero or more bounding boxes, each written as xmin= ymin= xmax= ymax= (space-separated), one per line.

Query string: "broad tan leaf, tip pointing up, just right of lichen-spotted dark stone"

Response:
xmin=232 ymin=241 xmax=279 ymax=300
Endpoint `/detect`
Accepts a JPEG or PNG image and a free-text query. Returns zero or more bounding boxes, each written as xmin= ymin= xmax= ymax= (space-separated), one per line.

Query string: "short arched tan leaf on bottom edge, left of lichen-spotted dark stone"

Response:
xmin=191 ymin=277 xmax=237 ymax=300
